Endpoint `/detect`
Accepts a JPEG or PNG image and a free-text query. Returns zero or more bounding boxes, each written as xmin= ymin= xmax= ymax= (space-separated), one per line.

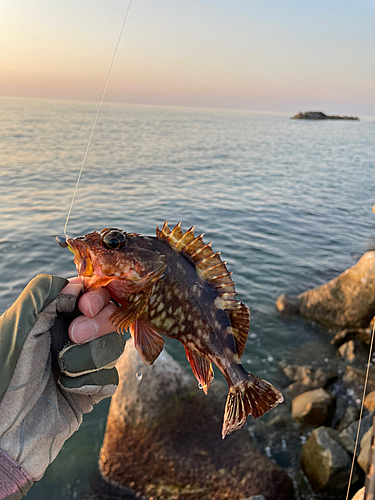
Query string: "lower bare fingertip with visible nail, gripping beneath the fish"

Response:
xmin=69 ymin=303 xmax=116 ymax=344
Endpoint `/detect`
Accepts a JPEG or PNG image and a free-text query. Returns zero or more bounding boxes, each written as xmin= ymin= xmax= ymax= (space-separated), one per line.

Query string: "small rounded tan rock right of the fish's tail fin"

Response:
xmin=292 ymin=389 xmax=335 ymax=426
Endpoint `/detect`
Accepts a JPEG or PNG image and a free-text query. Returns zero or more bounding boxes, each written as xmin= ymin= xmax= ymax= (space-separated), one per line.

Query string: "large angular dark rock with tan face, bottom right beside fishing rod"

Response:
xmin=300 ymin=427 xmax=358 ymax=496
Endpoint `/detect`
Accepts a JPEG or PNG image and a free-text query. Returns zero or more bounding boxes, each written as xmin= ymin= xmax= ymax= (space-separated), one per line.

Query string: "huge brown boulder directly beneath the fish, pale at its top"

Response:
xmin=99 ymin=341 xmax=293 ymax=500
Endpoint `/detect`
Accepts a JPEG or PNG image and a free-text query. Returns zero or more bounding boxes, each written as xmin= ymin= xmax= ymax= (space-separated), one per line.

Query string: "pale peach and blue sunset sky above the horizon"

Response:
xmin=0 ymin=0 xmax=375 ymax=116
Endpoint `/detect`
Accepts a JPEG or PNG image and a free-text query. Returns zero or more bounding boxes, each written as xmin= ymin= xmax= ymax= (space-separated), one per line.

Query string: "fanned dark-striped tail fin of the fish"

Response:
xmin=222 ymin=373 xmax=284 ymax=439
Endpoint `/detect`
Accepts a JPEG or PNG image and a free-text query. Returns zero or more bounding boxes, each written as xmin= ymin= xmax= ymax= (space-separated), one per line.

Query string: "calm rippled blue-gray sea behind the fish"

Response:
xmin=0 ymin=98 xmax=375 ymax=500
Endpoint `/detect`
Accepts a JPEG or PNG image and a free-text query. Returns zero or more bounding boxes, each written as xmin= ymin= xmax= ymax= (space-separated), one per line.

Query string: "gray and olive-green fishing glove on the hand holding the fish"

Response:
xmin=0 ymin=275 xmax=125 ymax=499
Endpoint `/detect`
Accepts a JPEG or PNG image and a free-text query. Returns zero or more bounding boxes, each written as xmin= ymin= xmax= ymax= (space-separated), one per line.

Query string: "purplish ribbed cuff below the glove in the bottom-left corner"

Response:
xmin=0 ymin=449 xmax=33 ymax=500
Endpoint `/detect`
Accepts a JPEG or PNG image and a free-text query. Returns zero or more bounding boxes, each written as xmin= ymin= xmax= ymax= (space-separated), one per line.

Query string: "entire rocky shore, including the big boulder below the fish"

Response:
xmin=90 ymin=251 xmax=375 ymax=500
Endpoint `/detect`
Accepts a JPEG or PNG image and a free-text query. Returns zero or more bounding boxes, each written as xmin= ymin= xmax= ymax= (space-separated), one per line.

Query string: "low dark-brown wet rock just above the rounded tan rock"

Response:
xmin=279 ymin=362 xmax=337 ymax=398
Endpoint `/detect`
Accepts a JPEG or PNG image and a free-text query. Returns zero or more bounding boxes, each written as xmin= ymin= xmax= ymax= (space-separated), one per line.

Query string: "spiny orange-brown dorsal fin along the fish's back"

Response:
xmin=156 ymin=221 xmax=250 ymax=357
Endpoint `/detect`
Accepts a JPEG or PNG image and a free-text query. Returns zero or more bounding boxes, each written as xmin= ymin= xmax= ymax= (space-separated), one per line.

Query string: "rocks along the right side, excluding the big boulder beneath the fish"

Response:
xmin=276 ymin=251 xmax=375 ymax=498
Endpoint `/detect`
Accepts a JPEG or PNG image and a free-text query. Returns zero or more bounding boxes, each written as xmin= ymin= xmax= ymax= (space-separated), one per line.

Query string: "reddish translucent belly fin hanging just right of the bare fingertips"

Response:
xmin=130 ymin=319 xmax=164 ymax=365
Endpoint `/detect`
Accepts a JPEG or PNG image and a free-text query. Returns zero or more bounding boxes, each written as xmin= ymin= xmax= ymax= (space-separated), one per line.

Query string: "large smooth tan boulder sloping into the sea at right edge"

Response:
xmin=276 ymin=250 xmax=375 ymax=328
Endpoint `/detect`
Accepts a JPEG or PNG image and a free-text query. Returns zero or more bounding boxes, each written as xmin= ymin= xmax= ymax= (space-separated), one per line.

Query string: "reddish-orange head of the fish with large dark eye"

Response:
xmin=64 ymin=228 xmax=167 ymax=302
